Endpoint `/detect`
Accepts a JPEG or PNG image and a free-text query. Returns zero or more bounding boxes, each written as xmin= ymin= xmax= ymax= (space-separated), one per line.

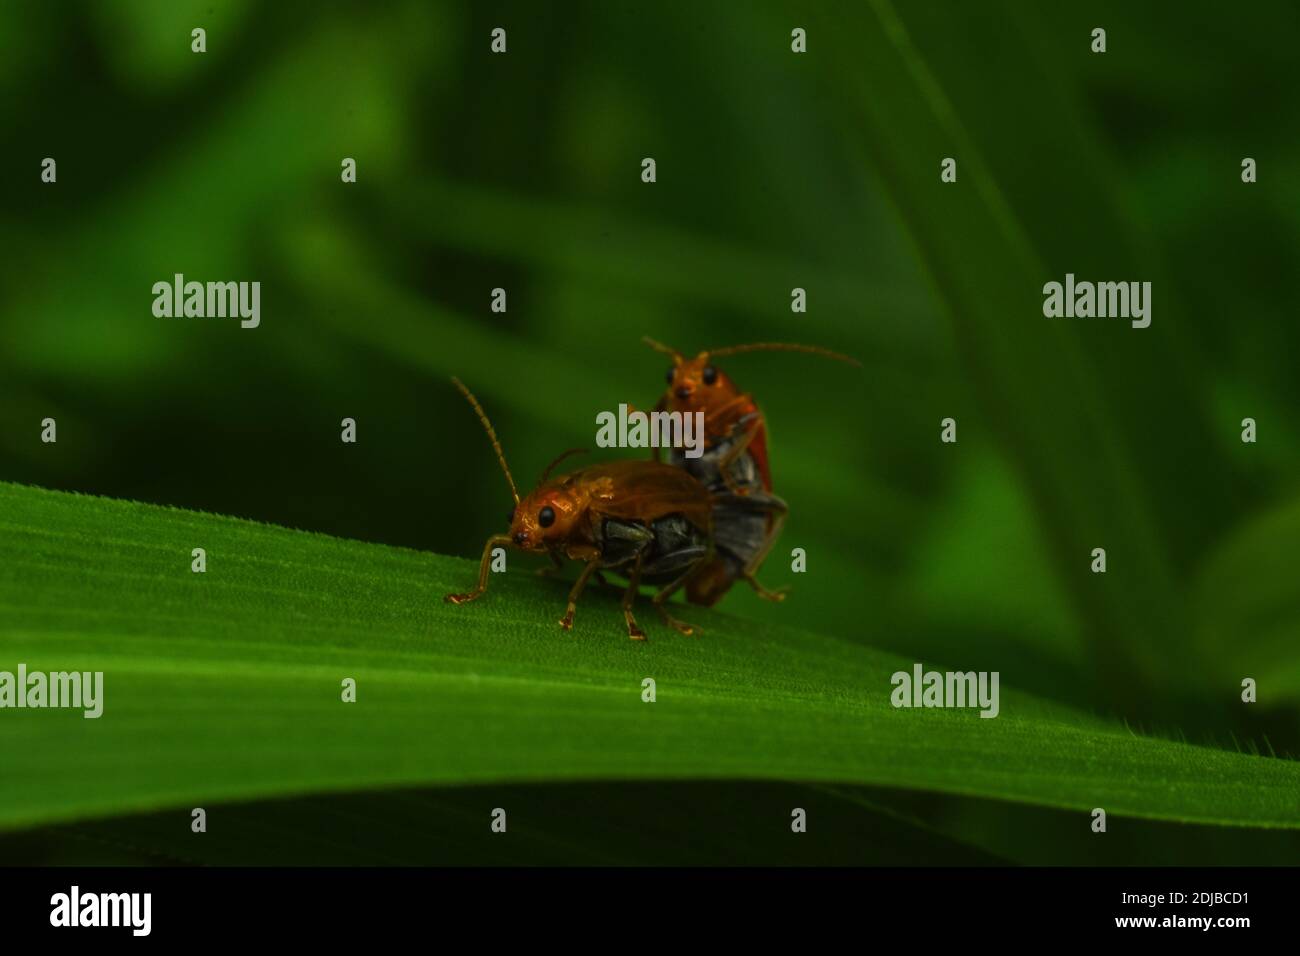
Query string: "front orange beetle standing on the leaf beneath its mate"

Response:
xmin=446 ymin=378 xmax=712 ymax=640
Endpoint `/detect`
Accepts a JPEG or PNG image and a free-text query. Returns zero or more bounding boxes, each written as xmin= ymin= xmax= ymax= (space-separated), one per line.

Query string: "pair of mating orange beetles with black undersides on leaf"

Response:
xmin=446 ymin=339 xmax=857 ymax=640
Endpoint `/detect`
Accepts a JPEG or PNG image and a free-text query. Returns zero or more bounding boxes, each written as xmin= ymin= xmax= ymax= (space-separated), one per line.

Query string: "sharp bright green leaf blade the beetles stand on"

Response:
xmin=0 ymin=484 xmax=1300 ymax=829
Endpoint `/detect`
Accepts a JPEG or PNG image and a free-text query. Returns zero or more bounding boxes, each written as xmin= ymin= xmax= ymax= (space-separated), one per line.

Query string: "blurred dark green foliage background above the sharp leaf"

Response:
xmin=0 ymin=0 xmax=1300 ymax=856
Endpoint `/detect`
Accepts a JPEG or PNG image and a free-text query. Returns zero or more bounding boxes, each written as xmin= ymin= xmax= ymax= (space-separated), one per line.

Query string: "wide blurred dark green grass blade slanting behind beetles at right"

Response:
xmin=818 ymin=0 xmax=1248 ymax=711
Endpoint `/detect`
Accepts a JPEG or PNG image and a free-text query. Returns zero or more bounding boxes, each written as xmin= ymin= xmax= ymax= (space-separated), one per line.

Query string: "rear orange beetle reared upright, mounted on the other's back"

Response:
xmin=644 ymin=338 xmax=862 ymax=606
